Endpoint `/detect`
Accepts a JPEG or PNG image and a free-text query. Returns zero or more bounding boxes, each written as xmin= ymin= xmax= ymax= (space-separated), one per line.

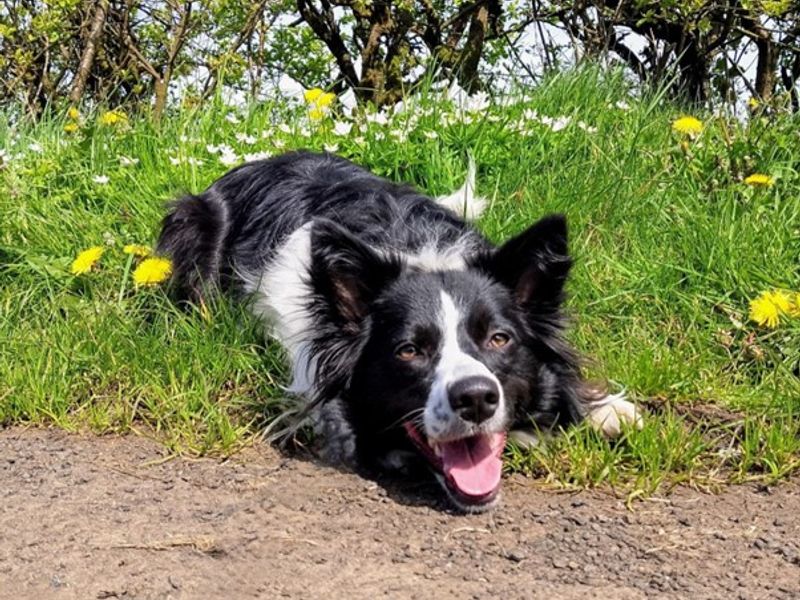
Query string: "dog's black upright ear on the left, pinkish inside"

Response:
xmin=311 ymin=219 xmax=401 ymax=327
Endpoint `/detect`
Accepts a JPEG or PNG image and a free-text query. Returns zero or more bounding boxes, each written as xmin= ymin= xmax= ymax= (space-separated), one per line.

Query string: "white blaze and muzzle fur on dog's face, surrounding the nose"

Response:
xmin=423 ymin=290 xmax=505 ymax=441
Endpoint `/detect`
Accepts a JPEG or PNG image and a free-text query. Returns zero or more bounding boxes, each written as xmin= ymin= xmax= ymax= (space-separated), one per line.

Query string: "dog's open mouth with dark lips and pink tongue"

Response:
xmin=404 ymin=423 xmax=506 ymax=510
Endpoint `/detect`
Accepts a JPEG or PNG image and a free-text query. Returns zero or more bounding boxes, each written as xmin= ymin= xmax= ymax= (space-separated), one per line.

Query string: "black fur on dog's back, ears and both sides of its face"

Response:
xmin=158 ymin=152 xmax=586 ymax=506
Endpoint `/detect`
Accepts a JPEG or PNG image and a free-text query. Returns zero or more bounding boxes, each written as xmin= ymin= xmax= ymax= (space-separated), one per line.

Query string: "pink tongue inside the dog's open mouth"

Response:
xmin=440 ymin=433 xmax=505 ymax=496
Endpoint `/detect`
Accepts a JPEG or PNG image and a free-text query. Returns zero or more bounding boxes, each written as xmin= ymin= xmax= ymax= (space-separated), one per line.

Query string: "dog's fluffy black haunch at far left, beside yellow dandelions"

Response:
xmin=156 ymin=190 xmax=228 ymax=302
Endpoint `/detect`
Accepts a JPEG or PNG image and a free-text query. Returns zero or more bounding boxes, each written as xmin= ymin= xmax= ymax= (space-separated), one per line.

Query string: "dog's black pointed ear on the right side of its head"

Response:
xmin=476 ymin=214 xmax=572 ymax=312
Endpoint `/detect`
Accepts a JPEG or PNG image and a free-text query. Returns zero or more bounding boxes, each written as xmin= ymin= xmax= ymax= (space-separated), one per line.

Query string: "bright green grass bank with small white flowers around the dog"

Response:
xmin=0 ymin=70 xmax=800 ymax=497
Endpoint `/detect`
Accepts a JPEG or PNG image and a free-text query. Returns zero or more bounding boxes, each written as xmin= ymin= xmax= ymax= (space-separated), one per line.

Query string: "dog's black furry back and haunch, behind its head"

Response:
xmin=158 ymin=152 xmax=485 ymax=300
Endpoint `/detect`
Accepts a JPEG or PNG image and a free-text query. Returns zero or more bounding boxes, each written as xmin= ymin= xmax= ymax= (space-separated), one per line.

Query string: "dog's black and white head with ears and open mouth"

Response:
xmin=311 ymin=215 xmax=571 ymax=510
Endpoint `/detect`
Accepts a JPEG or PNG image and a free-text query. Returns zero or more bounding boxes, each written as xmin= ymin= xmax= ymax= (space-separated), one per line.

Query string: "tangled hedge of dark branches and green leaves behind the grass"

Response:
xmin=0 ymin=0 xmax=800 ymax=119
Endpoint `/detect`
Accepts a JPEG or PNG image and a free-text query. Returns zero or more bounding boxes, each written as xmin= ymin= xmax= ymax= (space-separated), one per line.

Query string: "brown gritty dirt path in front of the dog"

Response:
xmin=0 ymin=428 xmax=800 ymax=600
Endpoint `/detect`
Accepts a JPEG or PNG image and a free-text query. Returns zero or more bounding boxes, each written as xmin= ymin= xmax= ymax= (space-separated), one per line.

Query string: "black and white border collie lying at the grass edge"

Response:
xmin=158 ymin=152 xmax=639 ymax=511
